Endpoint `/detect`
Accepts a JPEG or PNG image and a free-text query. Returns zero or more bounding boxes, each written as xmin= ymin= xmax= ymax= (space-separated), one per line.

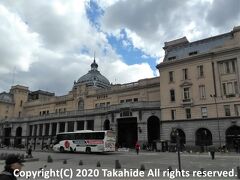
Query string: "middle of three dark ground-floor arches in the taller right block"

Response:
xmin=195 ymin=128 xmax=212 ymax=147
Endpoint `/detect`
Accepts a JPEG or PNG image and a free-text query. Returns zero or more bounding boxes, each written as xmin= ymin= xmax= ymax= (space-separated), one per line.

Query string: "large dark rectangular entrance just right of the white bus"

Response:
xmin=117 ymin=117 xmax=138 ymax=148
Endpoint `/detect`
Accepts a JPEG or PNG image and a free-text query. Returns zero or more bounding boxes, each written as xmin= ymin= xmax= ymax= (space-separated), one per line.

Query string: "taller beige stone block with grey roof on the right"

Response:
xmin=157 ymin=27 xmax=240 ymax=150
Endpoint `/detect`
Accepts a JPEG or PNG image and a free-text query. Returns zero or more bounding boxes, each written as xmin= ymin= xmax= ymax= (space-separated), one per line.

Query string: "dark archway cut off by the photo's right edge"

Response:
xmin=225 ymin=125 xmax=240 ymax=151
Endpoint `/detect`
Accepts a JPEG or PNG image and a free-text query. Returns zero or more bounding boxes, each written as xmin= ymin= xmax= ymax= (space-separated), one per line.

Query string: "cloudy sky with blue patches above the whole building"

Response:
xmin=0 ymin=0 xmax=240 ymax=95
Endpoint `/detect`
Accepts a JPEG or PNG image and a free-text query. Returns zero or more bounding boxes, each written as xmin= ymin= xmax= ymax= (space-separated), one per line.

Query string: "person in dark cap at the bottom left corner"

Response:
xmin=0 ymin=154 xmax=24 ymax=180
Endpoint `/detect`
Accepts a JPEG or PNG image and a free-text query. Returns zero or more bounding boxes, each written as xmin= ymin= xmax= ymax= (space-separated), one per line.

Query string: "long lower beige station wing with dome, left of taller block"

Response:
xmin=0 ymin=60 xmax=160 ymax=147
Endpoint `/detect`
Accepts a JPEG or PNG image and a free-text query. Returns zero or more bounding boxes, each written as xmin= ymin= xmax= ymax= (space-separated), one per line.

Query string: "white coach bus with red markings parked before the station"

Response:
xmin=53 ymin=130 xmax=116 ymax=153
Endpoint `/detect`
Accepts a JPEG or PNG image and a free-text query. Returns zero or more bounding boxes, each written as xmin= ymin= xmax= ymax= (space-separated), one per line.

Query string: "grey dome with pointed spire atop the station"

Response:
xmin=74 ymin=58 xmax=110 ymax=88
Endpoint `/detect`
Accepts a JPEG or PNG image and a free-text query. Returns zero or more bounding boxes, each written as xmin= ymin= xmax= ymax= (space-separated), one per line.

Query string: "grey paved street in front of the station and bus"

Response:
xmin=0 ymin=150 xmax=240 ymax=179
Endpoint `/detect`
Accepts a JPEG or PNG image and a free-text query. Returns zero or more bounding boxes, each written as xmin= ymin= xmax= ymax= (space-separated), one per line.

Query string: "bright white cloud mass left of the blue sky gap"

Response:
xmin=0 ymin=0 xmax=156 ymax=95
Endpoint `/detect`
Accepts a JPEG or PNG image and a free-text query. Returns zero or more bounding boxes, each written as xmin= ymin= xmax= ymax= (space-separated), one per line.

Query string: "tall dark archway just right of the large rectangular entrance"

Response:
xmin=147 ymin=116 xmax=160 ymax=148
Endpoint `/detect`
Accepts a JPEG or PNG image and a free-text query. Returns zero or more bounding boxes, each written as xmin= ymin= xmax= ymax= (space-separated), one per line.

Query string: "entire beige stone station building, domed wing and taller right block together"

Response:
xmin=0 ymin=27 xmax=240 ymax=149
